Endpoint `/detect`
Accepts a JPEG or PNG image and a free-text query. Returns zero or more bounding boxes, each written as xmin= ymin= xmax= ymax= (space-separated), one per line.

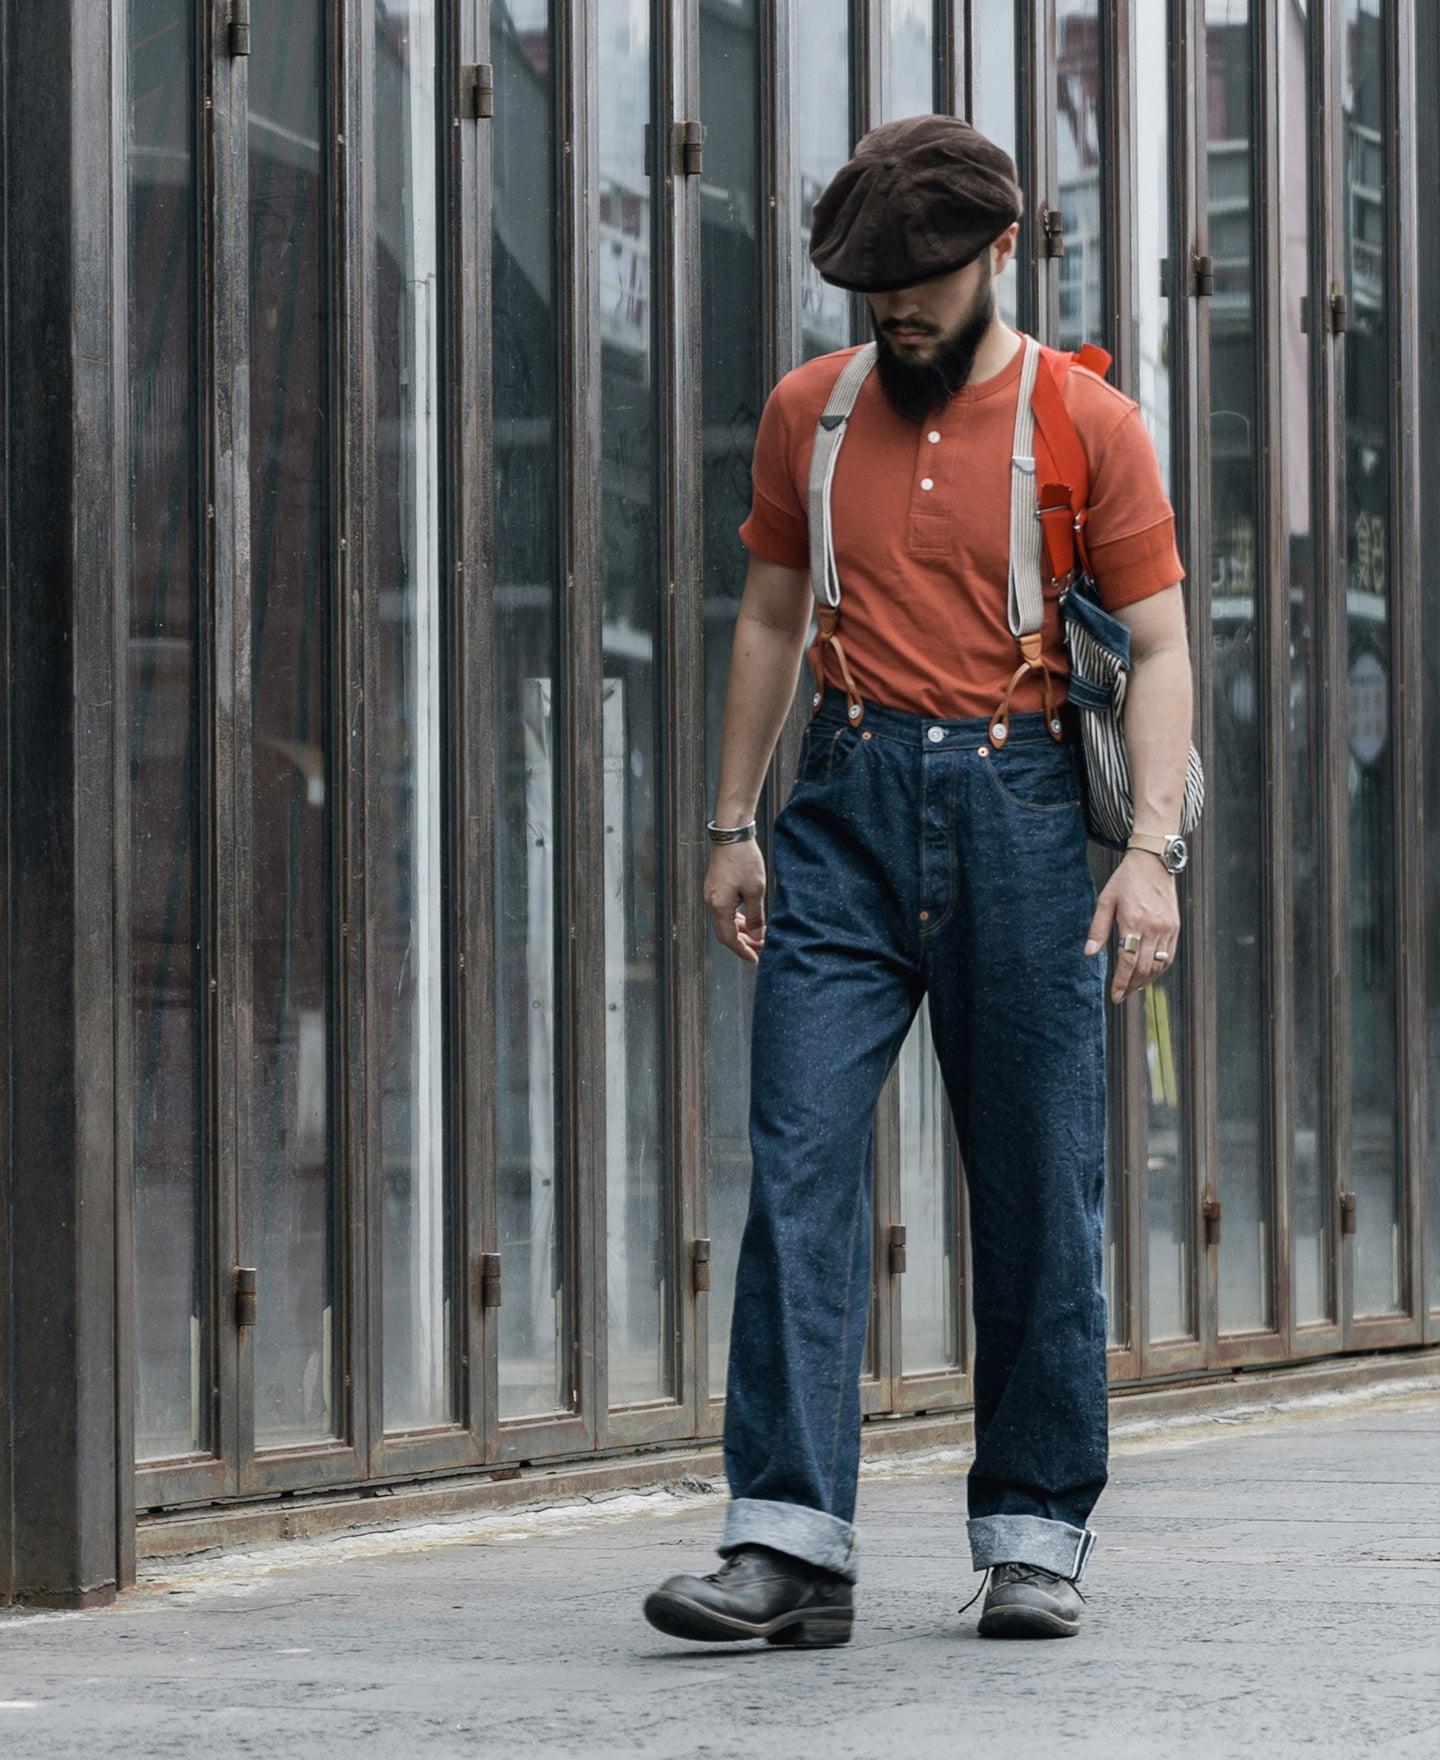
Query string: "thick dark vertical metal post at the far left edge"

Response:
xmin=0 ymin=0 xmax=129 ymax=1607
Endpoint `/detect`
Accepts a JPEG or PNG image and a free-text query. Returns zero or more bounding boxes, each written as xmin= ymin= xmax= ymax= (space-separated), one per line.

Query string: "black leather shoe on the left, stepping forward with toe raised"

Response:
xmin=644 ymin=1545 xmax=856 ymax=1649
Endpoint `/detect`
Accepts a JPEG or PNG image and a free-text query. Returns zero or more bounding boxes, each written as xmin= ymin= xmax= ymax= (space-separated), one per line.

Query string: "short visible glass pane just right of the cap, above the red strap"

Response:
xmin=1054 ymin=0 xmax=1105 ymax=348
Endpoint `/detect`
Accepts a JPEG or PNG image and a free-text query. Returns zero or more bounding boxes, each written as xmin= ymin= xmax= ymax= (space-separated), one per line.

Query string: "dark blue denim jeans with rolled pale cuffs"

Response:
xmin=718 ymin=688 xmax=1107 ymax=1580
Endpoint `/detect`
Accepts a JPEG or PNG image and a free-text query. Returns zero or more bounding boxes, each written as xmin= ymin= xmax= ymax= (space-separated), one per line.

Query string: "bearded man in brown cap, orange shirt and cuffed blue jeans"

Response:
xmin=644 ymin=116 xmax=1190 ymax=1646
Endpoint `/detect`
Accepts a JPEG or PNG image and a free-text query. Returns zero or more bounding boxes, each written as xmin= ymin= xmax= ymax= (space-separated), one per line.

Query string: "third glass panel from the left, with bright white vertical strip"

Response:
xmin=368 ymin=0 xmax=456 ymax=1429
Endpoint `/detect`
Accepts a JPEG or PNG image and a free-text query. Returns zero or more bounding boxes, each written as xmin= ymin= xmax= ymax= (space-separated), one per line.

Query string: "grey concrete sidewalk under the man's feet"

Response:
xmin=0 ymin=1392 xmax=1440 ymax=1760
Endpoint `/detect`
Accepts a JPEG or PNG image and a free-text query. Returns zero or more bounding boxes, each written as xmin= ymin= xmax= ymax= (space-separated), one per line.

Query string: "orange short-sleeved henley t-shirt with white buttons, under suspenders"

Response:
xmin=739 ymin=330 xmax=1185 ymax=718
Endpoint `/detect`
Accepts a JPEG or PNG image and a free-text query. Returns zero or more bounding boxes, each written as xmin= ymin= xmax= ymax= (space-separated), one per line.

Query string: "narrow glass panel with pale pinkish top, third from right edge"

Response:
xmin=1278 ymin=0 xmax=1334 ymax=1325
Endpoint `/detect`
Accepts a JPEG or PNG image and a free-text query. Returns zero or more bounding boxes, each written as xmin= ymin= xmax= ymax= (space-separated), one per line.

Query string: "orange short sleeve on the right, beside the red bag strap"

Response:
xmin=1086 ymin=405 xmax=1185 ymax=611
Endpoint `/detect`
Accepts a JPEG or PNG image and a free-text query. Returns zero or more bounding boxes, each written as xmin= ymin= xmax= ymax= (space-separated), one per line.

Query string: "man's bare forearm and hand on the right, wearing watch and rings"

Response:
xmin=1084 ymin=583 xmax=1192 ymax=1001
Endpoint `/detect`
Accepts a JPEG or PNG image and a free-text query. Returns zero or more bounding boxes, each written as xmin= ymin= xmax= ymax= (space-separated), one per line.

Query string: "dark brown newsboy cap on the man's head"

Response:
xmin=810 ymin=116 xmax=1023 ymax=294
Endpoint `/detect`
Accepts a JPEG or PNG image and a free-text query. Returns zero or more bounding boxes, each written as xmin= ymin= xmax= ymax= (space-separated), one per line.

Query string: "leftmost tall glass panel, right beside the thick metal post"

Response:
xmin=127 ymin=0 xmax=209 ymax=1461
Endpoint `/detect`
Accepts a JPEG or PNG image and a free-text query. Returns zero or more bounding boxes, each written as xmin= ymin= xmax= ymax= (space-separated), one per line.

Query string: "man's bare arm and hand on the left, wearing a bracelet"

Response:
xmin=704 ymin=553 xmax=813 ymax=966
